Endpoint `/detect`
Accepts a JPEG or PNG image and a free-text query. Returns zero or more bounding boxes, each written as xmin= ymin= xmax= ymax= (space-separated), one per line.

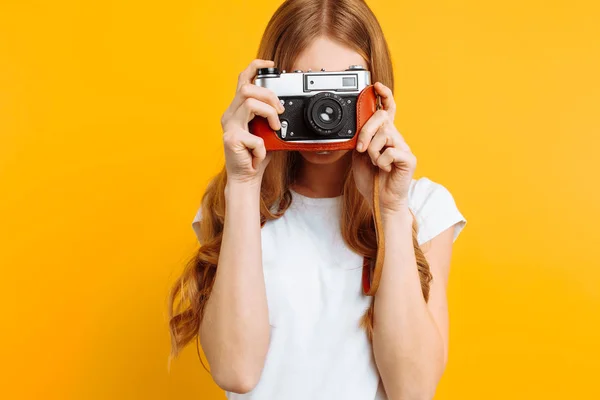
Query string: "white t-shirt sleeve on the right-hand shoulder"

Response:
xmin=409 ymin=177 xmax=467 ymax=244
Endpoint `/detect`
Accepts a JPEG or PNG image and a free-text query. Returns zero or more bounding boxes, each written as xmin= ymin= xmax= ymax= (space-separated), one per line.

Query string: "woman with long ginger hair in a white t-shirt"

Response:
xmin=169 ymin=0 xmax=466 ymax=400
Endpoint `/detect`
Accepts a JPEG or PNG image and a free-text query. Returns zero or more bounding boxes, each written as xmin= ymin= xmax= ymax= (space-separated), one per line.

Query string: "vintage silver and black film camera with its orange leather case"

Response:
xmin=249 ymin=65 xmax=377 ymax=151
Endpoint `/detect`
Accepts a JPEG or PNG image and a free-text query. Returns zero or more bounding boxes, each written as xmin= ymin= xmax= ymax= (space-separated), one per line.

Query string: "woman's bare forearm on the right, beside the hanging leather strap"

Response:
xmin=373 ymin=208 xmax=444 ymax=400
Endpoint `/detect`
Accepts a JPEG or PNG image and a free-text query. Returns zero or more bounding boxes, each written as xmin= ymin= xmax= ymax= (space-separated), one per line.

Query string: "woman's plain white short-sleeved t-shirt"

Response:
xmin=192 ymin=177 xmax=467 ymax=400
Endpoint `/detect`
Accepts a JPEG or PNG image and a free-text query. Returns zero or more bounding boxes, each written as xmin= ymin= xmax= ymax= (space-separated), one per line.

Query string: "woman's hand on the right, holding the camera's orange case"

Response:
xmin=352 ymin=82 xmax=417 ymax=214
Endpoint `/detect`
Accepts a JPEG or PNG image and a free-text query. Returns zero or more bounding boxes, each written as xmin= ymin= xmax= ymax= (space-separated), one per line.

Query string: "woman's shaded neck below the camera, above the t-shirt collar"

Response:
xmin=292 ymin=152 xmax=352 ymax=198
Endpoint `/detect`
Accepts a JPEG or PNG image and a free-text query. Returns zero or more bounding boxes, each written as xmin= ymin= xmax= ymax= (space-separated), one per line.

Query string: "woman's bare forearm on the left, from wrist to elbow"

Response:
xmin=200 ymin=184 xmax=269 ymax=392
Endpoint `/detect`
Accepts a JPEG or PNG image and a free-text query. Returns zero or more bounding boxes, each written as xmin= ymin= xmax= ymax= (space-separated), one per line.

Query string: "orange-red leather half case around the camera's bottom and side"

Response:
xmin=248 ymin=85 xmax=377 ymax=151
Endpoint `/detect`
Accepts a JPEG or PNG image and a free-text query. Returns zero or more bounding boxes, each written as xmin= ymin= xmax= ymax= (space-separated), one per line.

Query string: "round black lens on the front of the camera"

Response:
xmin=306 ymin=92 xmax=345 ymax=136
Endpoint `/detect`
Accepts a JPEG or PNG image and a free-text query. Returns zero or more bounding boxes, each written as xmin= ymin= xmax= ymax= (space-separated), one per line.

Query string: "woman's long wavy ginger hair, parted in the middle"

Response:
xmin=168 ymin=0 xmax=432 ymax=366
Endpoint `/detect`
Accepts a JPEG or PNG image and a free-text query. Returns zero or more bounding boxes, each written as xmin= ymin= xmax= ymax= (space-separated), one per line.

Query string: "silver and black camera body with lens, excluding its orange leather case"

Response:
xmin=254 ymin=65 xmax=371 ymax=143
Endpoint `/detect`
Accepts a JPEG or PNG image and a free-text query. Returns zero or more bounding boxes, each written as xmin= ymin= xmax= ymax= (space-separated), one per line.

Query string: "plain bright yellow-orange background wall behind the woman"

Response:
xmin=0 ymin=0 xmax=600 ymax=400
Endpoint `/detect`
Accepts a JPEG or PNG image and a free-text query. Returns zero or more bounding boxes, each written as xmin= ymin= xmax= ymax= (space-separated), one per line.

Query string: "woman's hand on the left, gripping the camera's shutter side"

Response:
xmin=221 ymin=59 xmax=283 ymax=183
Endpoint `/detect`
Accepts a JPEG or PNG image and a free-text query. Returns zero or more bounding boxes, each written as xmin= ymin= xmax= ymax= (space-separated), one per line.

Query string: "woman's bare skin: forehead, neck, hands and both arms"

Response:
xmin=200 ymin=37 xmax=454 ymax=400
